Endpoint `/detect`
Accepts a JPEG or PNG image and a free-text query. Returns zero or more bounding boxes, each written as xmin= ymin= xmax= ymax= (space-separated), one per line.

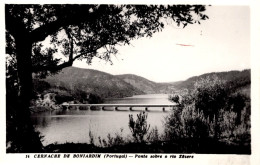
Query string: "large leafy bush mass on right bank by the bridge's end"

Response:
xmin=165 ymin=76 xmax=251 ymax=146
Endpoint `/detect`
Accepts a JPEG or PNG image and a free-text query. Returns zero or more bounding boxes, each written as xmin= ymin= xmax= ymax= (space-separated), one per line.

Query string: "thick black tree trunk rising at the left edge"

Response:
xmin=9 ymin=33 xmax=42 ymax=153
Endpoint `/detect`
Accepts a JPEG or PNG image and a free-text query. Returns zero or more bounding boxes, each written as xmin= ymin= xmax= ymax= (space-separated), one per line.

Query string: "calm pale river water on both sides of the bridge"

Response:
xmin=32 ymin=94 xmax=173 ymax=145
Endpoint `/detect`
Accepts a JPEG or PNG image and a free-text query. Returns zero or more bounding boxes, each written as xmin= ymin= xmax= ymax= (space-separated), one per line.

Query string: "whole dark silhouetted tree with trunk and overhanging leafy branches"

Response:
xmin=5 ymin=4 xmax=208 ymax=152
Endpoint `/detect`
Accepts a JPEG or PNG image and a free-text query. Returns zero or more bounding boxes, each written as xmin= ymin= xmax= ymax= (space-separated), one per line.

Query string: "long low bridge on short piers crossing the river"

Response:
xmin=62 ymin=104 xmax=177 ymax=112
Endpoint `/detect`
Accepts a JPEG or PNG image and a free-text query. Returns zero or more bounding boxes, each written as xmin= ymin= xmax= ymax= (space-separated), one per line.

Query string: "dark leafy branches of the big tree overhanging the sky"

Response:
xmin=6 ymin=4 xmax=208 ymax=75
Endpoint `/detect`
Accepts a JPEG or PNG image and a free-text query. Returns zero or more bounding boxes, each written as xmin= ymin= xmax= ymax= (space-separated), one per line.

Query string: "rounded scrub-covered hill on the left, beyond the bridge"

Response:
xmin=45 ymin=67 xmax=144 ymax=98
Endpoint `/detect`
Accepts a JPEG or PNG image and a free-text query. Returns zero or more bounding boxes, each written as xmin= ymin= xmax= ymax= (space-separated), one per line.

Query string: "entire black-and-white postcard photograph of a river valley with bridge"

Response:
xmin=1 ymin=0 xmax=259 ymax=164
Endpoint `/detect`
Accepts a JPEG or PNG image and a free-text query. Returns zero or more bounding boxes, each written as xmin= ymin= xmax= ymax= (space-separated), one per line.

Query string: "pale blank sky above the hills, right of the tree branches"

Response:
xmin=67 ymin=6 xmax=250 ymax=82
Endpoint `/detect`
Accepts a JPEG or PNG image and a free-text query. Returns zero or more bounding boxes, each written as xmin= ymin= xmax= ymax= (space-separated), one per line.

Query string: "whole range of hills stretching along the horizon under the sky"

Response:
xmin=35 ymin=67 xmax=251 ymax=101
